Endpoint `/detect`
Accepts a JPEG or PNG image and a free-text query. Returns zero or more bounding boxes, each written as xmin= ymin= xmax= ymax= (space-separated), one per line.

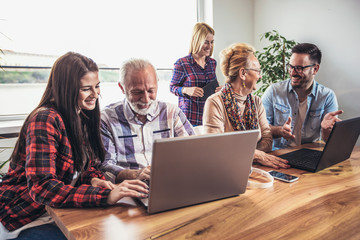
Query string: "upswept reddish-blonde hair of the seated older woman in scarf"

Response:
xmin=220 ymin=43 xmax=255 ymax=83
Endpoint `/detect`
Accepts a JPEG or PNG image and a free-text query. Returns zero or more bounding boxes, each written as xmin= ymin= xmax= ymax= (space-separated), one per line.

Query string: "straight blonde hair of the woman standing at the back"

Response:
xmin=189 ymin=22 xmax=215 ymax=56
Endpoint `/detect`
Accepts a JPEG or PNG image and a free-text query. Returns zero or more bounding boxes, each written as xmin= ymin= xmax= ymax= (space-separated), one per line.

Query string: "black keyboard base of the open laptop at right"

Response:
xmin=279 ymin=148 xmax=322 ymax=171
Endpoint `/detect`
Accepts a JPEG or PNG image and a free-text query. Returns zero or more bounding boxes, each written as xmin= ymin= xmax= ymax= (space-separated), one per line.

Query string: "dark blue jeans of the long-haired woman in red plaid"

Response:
xmin=14 ymin=223 xmax=66 ymax=240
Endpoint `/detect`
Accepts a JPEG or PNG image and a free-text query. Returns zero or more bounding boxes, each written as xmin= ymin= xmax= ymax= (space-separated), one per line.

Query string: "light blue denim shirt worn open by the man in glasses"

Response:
xmin=262 ymin=79 xmax=338 ymax=150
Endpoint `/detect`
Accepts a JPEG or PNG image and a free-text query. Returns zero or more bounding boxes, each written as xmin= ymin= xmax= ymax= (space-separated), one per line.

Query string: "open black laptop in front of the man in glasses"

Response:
xmin=279 ymin=117 xmax=360 ymax=172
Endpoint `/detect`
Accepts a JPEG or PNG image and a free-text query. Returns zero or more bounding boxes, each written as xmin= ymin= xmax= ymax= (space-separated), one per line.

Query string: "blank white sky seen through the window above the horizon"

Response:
xmin=0 ymin=0 xmax=196 ymax=68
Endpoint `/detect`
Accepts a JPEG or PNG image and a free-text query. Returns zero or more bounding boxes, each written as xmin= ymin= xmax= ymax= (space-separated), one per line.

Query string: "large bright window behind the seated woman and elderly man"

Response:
xmin=0 ymin=0 xmax=197 ymax=117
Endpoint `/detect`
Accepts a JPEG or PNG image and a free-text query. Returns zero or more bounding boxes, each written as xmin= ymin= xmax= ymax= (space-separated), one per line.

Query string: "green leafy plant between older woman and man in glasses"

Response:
xmin=255 ymin=30 xmax=297 ymax=96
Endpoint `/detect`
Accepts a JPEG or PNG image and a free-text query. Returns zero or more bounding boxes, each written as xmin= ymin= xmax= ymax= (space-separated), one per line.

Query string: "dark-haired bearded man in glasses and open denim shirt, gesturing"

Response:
xmin=262 ymin=43 xmax=343 ymax=149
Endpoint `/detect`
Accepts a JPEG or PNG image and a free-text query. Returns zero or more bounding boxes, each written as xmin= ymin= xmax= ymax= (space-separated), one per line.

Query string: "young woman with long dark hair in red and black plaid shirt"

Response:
xmin=0 ymin=52 xmax=148 ymax=239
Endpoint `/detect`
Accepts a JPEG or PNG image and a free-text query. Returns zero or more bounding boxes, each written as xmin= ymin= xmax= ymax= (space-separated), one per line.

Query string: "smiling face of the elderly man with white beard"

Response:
xmin=120 ymin=66 xmax=157 ymax=115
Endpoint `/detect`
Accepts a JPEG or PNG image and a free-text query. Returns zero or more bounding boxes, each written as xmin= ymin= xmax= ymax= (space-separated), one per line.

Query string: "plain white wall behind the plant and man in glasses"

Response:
xmin=211 ymin=0 xmax=360 ymax=144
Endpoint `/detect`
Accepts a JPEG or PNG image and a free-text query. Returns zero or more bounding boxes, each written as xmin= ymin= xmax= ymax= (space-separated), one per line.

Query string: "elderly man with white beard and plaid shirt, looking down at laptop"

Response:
xmin=101 ymin=59 xmax=195 ymax=183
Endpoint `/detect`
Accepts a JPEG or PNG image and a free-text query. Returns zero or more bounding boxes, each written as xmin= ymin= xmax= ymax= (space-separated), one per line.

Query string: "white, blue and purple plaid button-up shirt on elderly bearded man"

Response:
xmin=101 ymin=99 xmax=195 ymax=181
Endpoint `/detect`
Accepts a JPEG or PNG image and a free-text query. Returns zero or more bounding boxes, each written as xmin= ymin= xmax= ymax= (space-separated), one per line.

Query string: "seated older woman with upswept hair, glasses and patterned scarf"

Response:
xmin=203 ymin=43 xmax=290 ymax=168
